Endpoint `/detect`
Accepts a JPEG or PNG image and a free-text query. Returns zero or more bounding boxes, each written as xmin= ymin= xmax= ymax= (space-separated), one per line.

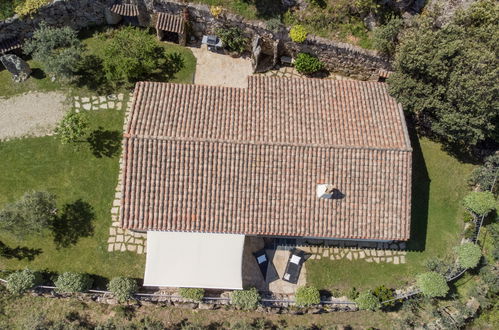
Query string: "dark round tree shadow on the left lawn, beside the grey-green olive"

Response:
xmin=52 ymin=199 xmax=95 ymax=248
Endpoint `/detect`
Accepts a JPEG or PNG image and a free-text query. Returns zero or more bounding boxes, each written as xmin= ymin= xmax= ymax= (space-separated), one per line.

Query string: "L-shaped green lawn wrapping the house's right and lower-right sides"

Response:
xmin=306 ymin=138 xmax=473 ymax=292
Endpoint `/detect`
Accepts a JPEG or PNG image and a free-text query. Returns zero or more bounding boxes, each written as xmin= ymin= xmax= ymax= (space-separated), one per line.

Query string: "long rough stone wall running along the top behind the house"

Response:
xmin=0 ymin=0 xmax=391 ymax=80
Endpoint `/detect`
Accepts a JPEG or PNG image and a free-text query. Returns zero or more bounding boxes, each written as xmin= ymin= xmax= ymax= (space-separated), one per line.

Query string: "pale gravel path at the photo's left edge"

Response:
xmin=0 ymin=92 xmax=67 ymax=140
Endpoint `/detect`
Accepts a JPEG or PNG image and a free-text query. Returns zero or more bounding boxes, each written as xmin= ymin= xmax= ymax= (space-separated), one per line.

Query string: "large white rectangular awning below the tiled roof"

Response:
xmin=144 ymin=231 xmax=244 ymax=289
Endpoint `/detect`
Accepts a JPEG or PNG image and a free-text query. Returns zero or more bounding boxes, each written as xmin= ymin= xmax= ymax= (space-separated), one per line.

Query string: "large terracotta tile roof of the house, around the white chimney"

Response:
xmin=120 ymin=77 xmax=412 ymax=240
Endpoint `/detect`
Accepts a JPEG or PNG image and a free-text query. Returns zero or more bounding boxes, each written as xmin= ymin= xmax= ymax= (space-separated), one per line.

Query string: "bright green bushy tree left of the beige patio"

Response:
xmin=99 ymin=26 xmax=184 ymax=86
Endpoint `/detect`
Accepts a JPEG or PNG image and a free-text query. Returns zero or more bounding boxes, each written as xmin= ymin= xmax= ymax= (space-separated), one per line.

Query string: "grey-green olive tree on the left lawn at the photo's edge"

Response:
xmin=0 ymin=191 xmax=57 ymax=237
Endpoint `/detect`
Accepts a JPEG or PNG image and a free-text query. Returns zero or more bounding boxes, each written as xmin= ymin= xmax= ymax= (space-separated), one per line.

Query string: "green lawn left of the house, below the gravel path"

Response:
xmin=0 ymin=110 xmax=145 ymax=278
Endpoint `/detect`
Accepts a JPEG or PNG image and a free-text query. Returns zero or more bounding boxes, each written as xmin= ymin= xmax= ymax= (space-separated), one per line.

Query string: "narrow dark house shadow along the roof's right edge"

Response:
xmin=408 ymin=123 xmax=430 ymax=251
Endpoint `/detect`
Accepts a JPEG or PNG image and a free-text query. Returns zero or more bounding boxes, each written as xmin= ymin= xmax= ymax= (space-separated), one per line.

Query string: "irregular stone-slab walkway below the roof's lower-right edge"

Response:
xmin=300 ymin=246 xmax=407 ymax=265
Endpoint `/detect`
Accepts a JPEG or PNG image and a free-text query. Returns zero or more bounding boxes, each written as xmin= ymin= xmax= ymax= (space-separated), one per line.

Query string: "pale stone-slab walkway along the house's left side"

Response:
xmin=106 ymin=94 xmax=147 ymax=254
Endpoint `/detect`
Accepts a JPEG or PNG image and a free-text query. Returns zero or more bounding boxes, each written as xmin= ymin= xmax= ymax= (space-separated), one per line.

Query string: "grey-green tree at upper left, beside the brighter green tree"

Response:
xmin=24 ymin=22 xmax=83 ymax=79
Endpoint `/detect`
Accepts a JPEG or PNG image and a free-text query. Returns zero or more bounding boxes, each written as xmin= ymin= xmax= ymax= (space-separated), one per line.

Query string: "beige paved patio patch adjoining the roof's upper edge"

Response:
xmin=189 ymin=46 xmax=253 ymax=87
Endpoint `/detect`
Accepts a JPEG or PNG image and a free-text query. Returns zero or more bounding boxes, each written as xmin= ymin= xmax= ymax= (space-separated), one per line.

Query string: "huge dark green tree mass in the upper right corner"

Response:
xmin=388 ymin=0 xmax=499 ymax=153
